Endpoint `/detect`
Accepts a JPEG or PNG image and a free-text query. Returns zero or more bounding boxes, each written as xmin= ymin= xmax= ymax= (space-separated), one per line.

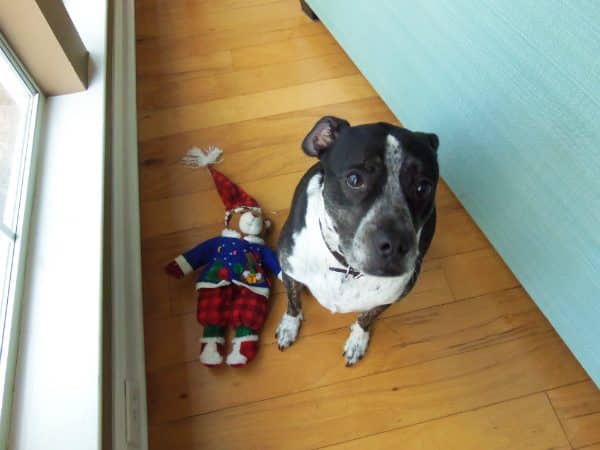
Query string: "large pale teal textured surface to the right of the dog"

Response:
xmin=309 ymin=0 xmax=600 ymax=384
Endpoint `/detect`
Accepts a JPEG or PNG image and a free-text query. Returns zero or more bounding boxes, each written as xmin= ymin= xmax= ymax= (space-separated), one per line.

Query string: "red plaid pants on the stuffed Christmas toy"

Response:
xmin=196 ymin=284 xmax=267 ymax=332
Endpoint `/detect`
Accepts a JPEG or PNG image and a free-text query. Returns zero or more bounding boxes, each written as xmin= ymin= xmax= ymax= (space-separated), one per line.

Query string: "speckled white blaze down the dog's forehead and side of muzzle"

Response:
xmin=346 ymin=134 xmax=416 ymax=268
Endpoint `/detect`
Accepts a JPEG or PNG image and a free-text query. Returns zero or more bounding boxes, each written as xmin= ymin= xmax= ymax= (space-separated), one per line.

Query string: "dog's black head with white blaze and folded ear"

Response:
xmin=302 ymin=116 xmax=438 ymax=276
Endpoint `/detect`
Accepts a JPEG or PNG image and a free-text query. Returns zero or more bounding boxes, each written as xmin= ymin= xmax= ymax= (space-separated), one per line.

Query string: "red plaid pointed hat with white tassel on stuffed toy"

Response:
xmin=182 ymin=147 xmax=262 ymax=227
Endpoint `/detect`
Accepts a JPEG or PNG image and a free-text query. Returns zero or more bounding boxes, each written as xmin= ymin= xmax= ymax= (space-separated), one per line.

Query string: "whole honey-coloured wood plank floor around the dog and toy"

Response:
xmin=136 ymin=0 xmax=600 ymax=450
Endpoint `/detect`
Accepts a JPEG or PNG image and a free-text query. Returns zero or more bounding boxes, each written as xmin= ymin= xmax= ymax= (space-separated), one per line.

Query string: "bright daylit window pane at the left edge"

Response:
xmin=0 ymin=40 xmax=39 ymax=404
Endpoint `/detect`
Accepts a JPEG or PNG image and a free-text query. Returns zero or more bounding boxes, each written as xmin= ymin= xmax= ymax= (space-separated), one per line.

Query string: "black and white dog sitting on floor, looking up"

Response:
xmin=276 ymin=116 xmax=438 ymax=366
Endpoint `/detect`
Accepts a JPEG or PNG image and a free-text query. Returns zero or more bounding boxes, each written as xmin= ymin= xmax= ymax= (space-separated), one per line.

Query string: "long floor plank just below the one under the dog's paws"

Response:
xmin=150 ymin=331 xmax=585 ymax=450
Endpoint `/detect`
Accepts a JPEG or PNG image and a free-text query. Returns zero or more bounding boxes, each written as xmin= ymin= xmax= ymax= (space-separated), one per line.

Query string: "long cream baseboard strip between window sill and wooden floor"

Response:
xmin=109 ymin=0 xmax=148 ymax=450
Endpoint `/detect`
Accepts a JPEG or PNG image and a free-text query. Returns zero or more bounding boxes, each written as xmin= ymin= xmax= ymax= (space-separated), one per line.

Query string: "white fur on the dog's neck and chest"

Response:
xmin=288 ymin=175 xmax=411 ymax=313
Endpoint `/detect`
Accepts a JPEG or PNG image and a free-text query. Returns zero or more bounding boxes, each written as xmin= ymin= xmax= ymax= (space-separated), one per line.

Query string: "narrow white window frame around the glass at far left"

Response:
xmin=0 ymin=34 xmax=45 ymax=448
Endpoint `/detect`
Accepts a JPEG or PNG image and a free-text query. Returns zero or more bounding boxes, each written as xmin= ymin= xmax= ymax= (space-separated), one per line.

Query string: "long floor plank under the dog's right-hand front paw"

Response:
xmin=148 ymin=290 xmax=551 ymax=423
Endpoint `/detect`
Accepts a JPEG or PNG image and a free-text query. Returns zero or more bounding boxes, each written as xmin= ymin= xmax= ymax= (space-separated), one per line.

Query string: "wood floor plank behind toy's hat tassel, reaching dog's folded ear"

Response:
xmin=140 ymin=99 xmax=396 ymax=204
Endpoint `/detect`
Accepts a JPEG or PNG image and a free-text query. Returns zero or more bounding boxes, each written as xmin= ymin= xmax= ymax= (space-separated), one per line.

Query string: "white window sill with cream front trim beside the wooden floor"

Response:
xmin=0 ymin=0 xmax=147 ymax=450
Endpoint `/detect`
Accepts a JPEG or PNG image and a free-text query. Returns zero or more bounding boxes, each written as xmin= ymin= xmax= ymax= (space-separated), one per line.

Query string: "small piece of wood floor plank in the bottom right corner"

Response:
xmin=548 ymin=380 xmax=600 ymax=448
